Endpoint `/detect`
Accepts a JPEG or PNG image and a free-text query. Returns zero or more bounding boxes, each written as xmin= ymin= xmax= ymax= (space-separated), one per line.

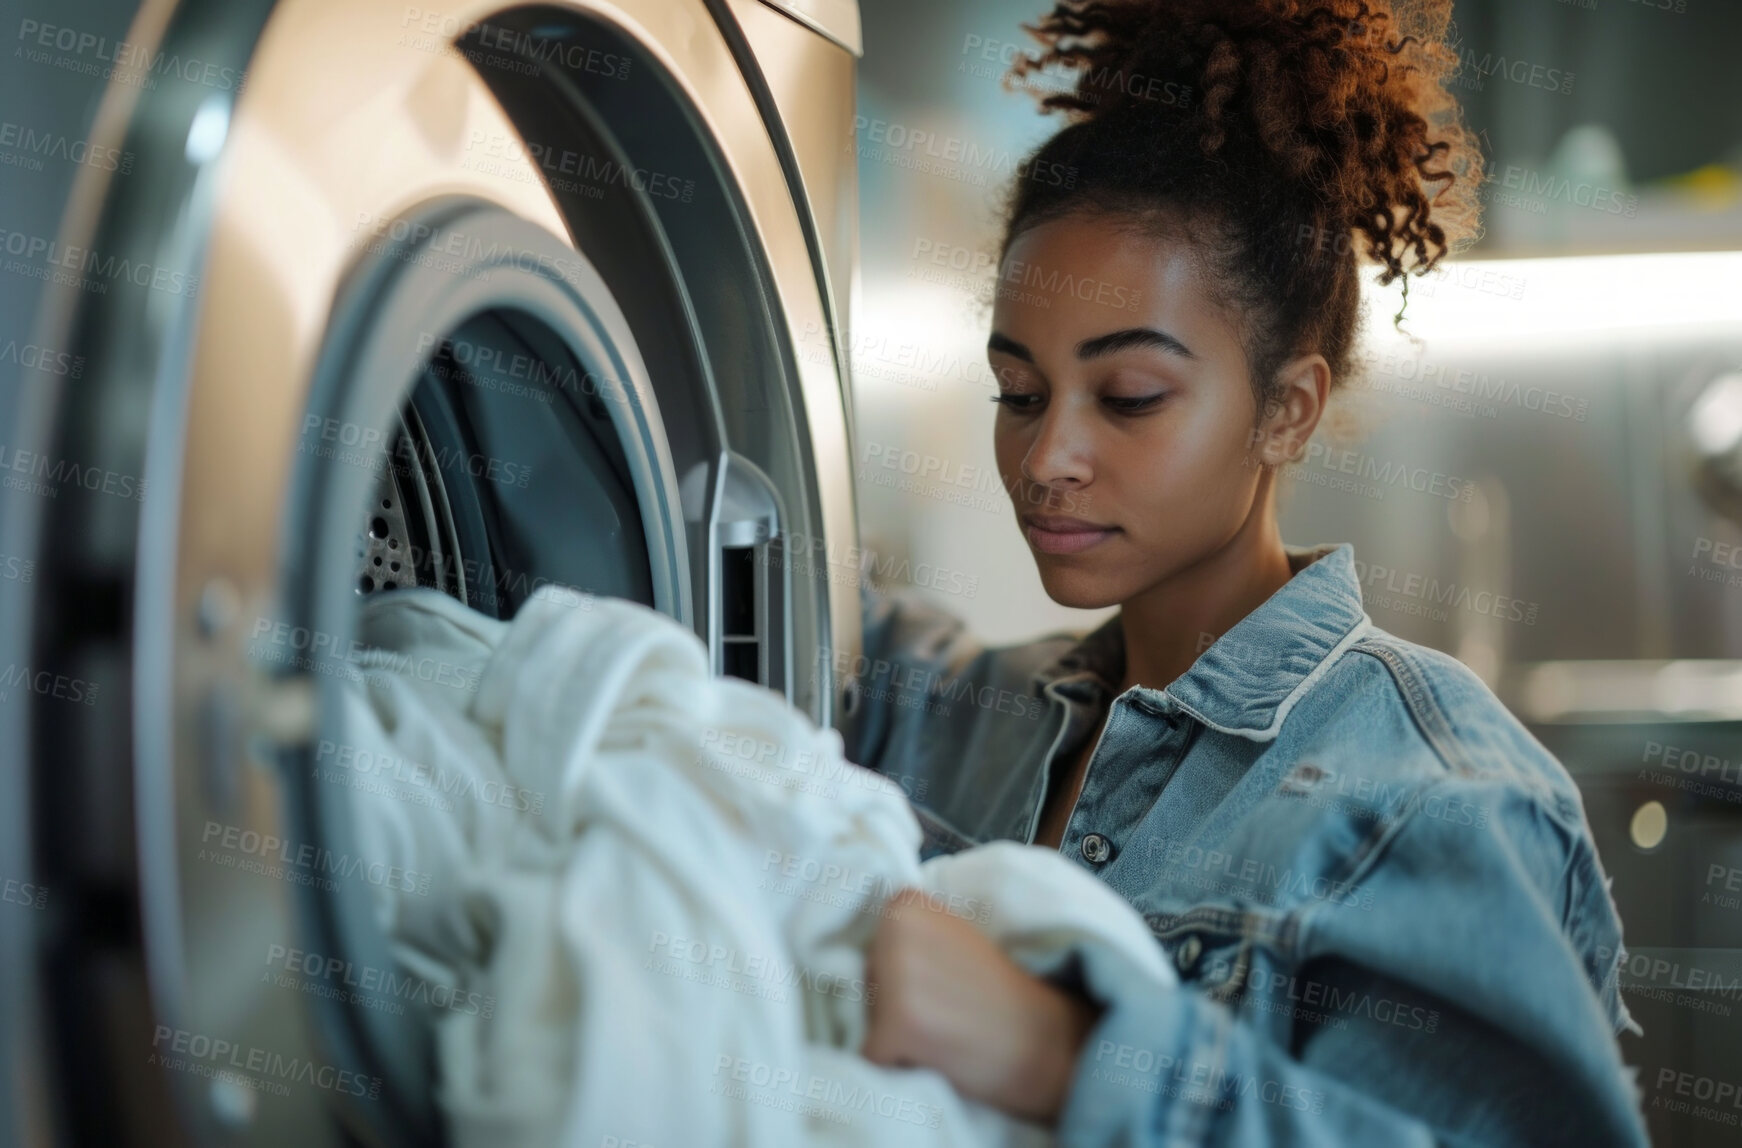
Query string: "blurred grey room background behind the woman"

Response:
xmin=852 ymin=0 xmax=1742 ymax=1145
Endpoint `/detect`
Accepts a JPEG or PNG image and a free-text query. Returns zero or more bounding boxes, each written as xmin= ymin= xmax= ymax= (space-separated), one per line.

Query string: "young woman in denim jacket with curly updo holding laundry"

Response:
xmin=847 ymin=0 xmax=1644 ymax=1146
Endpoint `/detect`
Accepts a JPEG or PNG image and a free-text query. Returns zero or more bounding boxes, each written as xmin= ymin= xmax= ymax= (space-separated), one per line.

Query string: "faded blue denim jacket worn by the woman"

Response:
xmin=843 ymin=544 xmax=1646 ymax=1148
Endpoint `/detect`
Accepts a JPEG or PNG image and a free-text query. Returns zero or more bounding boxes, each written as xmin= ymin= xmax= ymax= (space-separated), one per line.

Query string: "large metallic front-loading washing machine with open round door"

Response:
xmin=0 ymin=0 xmax=859 ymax=1145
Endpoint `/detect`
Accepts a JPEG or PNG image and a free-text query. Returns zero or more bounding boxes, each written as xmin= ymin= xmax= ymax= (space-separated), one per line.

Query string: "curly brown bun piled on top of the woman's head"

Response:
xmin=1007 ymin=0 xmax=1482 ymax=284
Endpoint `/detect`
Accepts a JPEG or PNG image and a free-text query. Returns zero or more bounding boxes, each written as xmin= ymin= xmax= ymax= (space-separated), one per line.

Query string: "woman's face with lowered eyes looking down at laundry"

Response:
xmin=988 ymin=216 xmax=1289 ymax=608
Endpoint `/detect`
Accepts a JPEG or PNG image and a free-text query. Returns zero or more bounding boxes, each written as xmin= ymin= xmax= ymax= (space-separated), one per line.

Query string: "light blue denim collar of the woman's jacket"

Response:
xmin=1033 ymin=542 xmax=1371 ymax=742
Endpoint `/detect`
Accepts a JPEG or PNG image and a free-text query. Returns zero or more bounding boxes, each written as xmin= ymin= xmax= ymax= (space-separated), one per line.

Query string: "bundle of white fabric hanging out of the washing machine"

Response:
xmin=345 ymin=587 xmax=1174 ymax=1148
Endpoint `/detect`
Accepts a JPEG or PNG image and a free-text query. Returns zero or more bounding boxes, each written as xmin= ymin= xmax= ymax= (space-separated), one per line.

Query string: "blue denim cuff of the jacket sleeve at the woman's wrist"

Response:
xmin=1057 ymin=949 xmax=1233 ymax=1145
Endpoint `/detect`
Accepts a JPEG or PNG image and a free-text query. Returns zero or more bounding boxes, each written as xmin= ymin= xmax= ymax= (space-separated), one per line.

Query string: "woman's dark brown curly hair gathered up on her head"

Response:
xmin=998 ymin=0 xmax=1482 ymax=418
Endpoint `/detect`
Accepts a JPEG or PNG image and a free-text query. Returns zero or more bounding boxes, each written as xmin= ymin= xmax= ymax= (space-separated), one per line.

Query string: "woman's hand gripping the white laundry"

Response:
xmin=861 ymin=888 xmax=1099 ymax=1125
